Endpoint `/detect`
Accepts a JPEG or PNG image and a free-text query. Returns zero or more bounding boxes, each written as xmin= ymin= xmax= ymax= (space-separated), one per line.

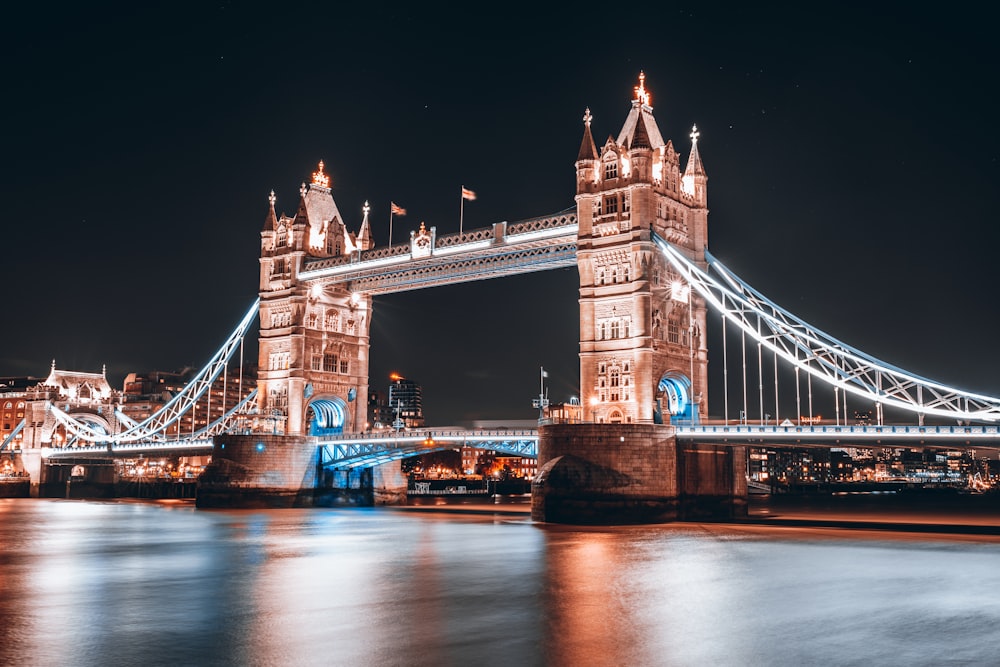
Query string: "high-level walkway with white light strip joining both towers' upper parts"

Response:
xmin=299 ymin=211 xmax=577 ymax=295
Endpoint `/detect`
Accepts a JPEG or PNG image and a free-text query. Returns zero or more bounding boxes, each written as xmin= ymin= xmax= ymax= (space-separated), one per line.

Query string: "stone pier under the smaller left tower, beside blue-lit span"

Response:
xmin=195 ymin=434 xmax=406 ymax=508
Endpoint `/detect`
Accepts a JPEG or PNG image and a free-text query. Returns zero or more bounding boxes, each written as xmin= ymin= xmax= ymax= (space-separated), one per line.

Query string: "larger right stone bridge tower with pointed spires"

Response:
xmin=576 ymin=74 xmax=708 ymax=423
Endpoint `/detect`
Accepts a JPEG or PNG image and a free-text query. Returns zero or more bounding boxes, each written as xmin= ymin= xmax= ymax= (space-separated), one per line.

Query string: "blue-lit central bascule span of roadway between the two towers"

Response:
xmin=320 ymin=431 xmax=538 ymax=470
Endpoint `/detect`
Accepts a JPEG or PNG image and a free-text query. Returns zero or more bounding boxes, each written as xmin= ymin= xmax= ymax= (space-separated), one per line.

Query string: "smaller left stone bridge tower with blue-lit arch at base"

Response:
xmin=257 ymin=162 xmax=372 ymax=435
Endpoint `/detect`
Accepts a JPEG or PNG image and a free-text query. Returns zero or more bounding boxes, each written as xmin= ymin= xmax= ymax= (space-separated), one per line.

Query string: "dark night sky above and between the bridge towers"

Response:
xmin=0 ymin=2 xmax=1000 ymax=424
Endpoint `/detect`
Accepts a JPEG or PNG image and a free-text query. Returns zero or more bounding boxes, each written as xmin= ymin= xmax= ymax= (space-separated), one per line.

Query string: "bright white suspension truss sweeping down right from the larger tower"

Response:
xmin=653 ymin=234 xmax=1000 ymax=422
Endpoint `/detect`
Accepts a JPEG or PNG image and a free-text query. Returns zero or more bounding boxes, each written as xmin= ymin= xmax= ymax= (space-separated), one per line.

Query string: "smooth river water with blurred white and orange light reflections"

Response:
xmin=0 ymin=499 xmax=1000 ymax=667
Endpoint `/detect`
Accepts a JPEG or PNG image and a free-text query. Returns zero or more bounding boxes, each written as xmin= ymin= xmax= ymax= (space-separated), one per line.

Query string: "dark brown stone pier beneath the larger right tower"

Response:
xmin=531 ymin=424 xmax=747 ymax=525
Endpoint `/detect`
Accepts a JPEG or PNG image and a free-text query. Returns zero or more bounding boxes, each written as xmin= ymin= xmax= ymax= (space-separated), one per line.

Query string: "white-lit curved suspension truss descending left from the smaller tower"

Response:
xmin=47 ymin=299 xmax=260 ymax=444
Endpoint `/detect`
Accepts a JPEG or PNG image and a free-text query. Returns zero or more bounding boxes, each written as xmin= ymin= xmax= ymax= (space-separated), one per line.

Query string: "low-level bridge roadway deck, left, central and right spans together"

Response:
xmin=45 ymin=424 xmax=1000 ymax=468
